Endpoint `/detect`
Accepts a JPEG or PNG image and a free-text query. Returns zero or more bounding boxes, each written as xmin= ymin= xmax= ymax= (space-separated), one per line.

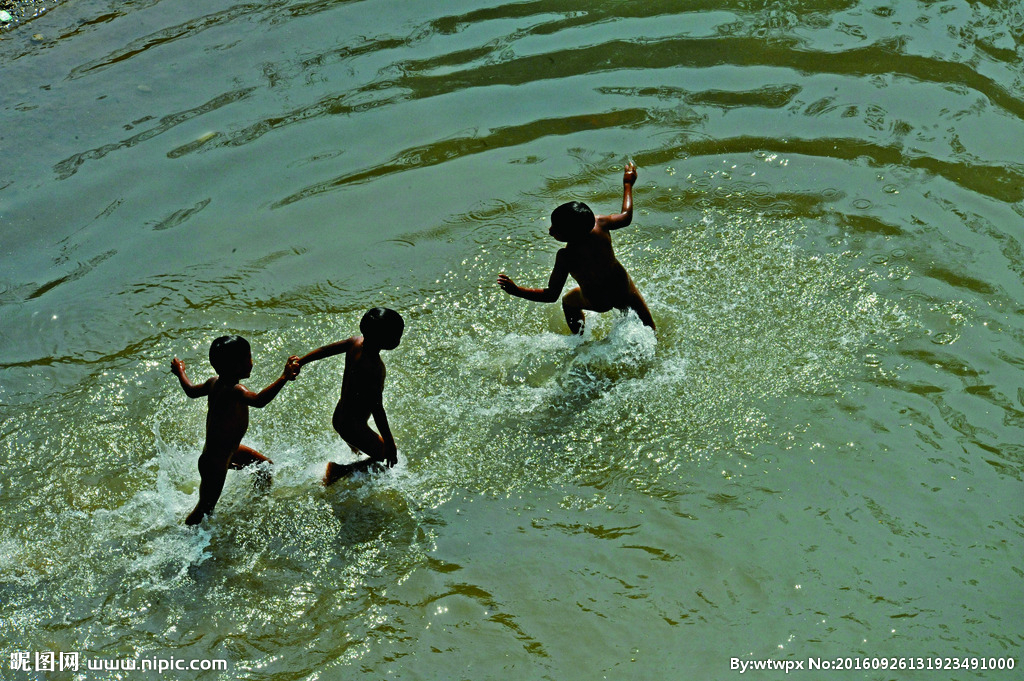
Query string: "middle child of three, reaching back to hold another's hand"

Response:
xmin=298 ymin=307 xmax=406 ymax=484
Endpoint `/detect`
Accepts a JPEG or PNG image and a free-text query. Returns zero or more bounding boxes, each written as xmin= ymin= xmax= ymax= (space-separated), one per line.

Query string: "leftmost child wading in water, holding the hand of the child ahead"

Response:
xmin=171 ymin=336 xmax=299 ymax=525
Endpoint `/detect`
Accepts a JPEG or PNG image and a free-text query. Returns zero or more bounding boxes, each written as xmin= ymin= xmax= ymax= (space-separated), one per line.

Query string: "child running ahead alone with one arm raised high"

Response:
xmin=498 ymin=162 xmax=654 ymax=334
